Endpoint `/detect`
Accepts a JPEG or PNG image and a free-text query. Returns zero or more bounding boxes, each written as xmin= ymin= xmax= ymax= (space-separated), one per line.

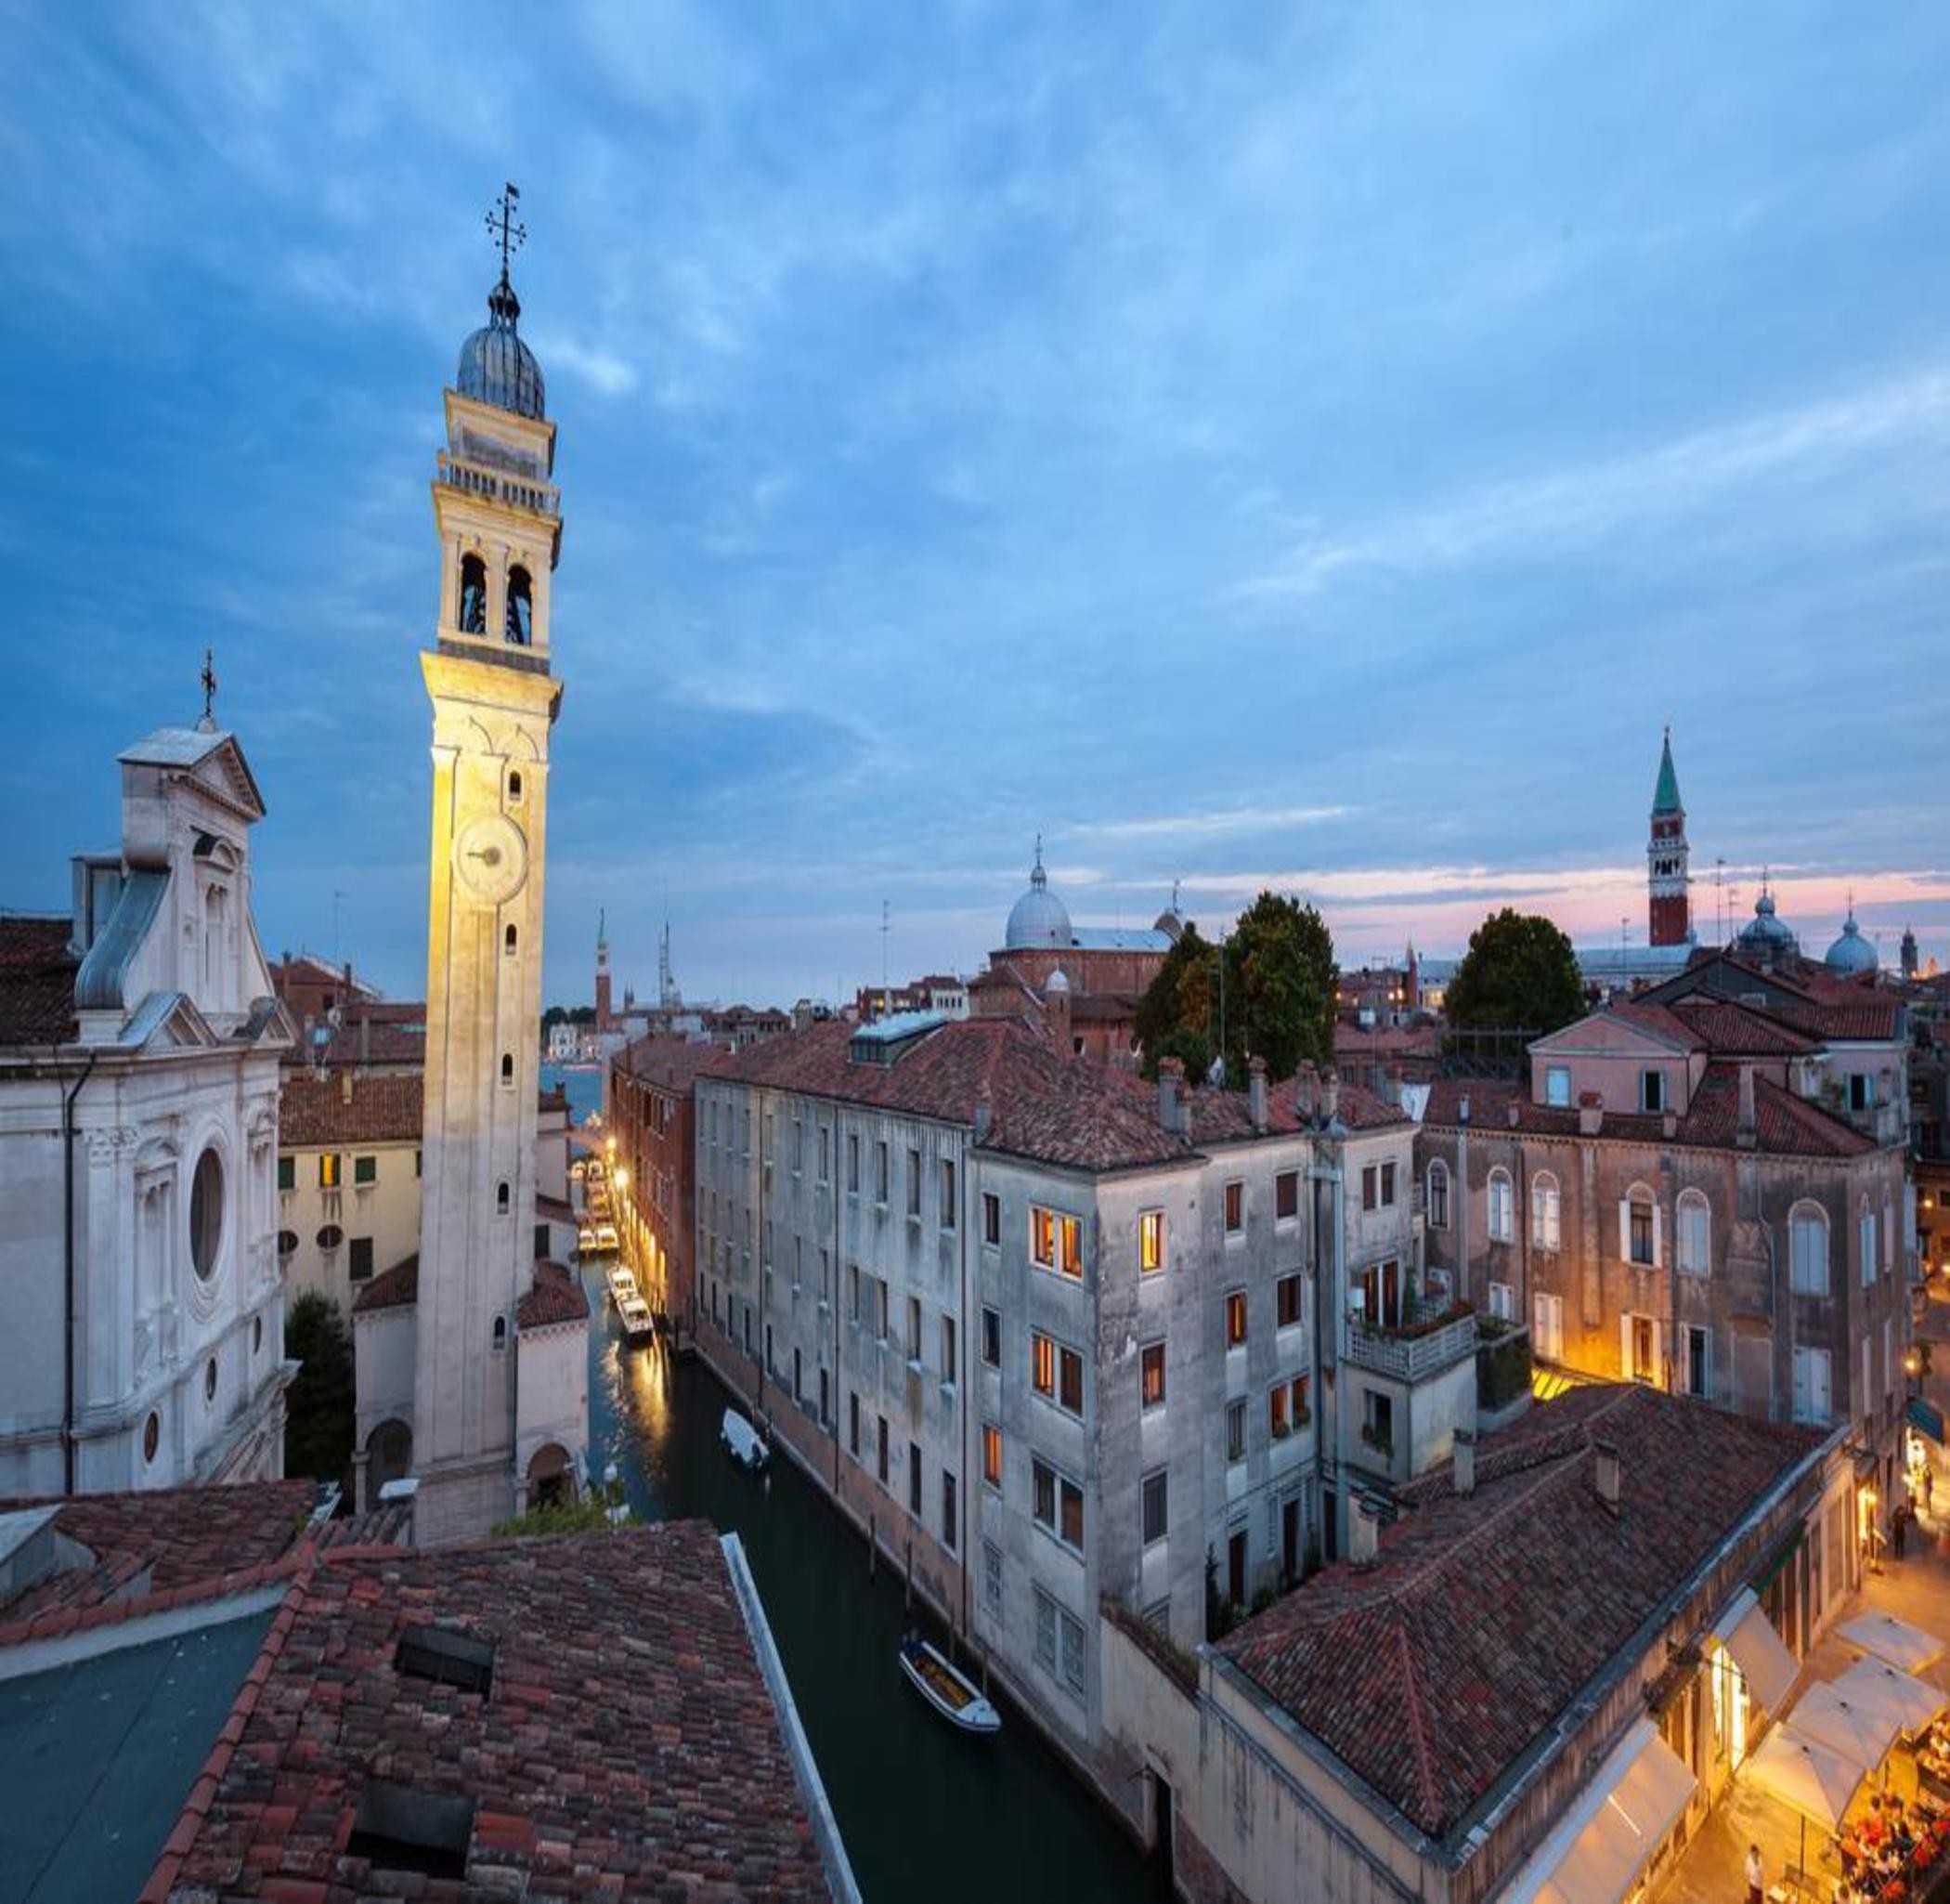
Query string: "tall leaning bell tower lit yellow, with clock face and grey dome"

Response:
xmin=413 ymin=186 xmax=569 ymax=1543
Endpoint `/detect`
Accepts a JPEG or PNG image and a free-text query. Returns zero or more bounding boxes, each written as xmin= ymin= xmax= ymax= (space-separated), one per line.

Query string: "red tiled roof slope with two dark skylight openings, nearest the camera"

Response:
xmin=162 ymin=1521 xmax=826 ymax=1904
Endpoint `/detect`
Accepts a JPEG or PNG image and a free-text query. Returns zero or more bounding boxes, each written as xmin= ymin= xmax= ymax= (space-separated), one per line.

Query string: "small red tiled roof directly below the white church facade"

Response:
xmin=0 ymin=1480 xmax=318 ymax=1643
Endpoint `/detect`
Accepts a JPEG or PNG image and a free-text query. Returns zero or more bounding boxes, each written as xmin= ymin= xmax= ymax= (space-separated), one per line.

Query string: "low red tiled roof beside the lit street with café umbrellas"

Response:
xmin=1219 ymin=1385 xmax=1821 ymax=1838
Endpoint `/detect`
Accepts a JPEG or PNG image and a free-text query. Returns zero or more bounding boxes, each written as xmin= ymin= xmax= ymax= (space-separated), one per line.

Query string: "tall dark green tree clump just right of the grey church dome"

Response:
xmin=1135 ymin=892 xmax=1338 ymax=1090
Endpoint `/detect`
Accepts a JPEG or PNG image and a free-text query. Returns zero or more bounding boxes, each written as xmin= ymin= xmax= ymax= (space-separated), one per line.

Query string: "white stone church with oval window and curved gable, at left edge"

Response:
xmin=0 ymin=714 xmax=294 ymax=1496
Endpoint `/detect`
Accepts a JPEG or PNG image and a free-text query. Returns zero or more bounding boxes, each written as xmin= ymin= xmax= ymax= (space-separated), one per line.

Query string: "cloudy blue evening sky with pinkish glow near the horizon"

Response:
xmin=0 ymin=0 xmax=1950 ymax=1003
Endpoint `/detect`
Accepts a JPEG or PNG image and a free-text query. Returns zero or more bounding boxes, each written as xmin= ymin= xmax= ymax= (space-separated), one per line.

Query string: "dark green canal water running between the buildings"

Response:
xmin=589 ymin=1276 xmax=1170 ymax=1904
